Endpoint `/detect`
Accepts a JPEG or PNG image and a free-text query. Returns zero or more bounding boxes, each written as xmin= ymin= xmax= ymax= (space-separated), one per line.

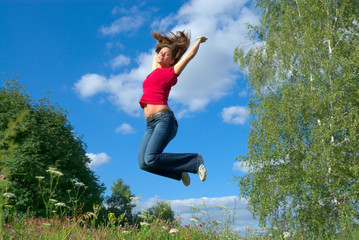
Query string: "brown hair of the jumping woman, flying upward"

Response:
xmin=151 ymin=31 xmax=191 ymax=65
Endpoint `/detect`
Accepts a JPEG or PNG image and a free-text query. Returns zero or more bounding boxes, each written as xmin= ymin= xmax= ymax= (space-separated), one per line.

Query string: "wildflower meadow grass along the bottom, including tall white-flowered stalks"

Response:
xmin=0 ymin=175 xmax=359 ymax=240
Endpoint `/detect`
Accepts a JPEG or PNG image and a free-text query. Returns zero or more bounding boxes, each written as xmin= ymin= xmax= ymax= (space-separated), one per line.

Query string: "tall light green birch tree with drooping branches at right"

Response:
xmin=234 ymin=0 xmax=359 ymax=238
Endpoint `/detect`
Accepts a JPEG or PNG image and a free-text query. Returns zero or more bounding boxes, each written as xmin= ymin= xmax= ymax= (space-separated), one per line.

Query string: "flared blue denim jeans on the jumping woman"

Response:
xmin=138 ymin=112 xmax=199 ymax=180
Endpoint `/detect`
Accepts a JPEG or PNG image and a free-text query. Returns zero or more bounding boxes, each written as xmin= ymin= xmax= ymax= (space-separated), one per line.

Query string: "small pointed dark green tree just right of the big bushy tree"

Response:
xmin=106 ymin=178 xmax=136 ymax=224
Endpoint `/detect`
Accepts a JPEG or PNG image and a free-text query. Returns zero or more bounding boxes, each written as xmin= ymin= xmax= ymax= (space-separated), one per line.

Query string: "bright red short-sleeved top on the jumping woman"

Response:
xmin=139 ymin=66 xmax=179 ymax=108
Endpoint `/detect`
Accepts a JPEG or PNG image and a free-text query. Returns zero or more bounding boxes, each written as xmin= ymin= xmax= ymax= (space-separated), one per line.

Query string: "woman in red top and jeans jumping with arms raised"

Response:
xmin=138 ymin=31 xmax=207 ymax=186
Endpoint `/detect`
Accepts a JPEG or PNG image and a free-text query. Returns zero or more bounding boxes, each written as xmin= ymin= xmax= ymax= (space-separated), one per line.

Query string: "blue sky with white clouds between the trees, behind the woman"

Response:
xmin=0 ymin=0 xmax=258 ymax=229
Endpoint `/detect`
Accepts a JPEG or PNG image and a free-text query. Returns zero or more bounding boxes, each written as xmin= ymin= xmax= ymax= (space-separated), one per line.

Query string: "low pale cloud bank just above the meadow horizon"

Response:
xmin=135 ymin=196 xmax=258 ymax=231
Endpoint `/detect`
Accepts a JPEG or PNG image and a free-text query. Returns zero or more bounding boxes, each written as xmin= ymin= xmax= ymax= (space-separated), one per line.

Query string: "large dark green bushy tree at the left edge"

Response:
xmin=0 ymin=79 xmax=104 ymax=216
